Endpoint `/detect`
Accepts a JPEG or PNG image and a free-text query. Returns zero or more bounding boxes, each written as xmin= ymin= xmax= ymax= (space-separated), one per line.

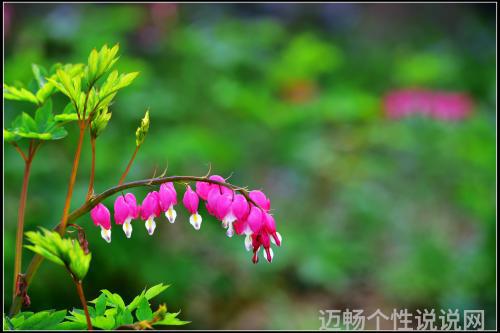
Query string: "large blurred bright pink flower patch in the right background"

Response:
xmin=383 ymin=89 xmax=473 ymax=120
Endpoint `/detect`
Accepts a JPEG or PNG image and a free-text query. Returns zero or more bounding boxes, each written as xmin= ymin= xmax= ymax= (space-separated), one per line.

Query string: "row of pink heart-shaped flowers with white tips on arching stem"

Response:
xmin=90 ymin=175 xmax=281 ymax=263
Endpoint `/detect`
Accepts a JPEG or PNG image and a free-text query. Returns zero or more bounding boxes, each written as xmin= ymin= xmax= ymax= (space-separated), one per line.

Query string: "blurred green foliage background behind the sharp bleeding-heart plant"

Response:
xmin=3 ymin=3 xmax=496 ymax=329
